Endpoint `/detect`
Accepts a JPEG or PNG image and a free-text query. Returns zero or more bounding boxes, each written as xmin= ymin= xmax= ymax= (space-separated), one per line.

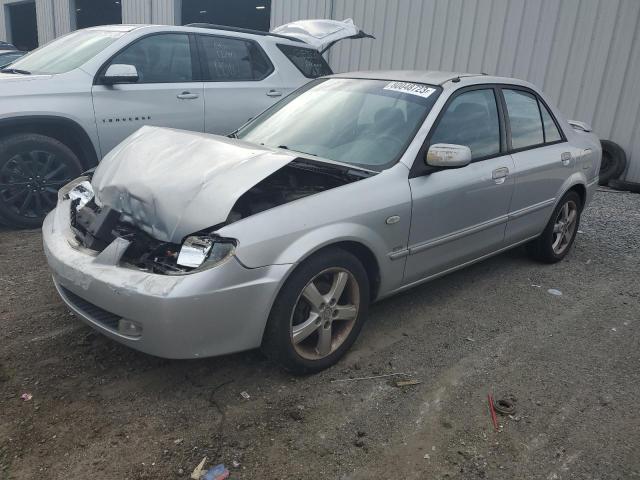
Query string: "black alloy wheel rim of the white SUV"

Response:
xmin=0 ymin=150 xmax=77 ymax=218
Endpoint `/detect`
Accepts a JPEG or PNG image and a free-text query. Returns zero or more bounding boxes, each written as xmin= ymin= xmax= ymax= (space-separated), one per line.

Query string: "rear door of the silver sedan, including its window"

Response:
xmin=501 ymin=86 xmax=580 ymax=243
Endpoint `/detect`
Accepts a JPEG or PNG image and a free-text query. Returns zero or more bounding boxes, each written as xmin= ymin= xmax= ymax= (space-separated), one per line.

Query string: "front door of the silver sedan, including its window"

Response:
xmin=405 ymin=85 xmax=514 ymax=283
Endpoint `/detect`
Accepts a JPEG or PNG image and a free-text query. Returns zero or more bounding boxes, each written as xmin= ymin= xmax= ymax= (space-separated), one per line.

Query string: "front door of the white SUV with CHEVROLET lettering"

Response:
xmin=92 ymin=33 xmax=204 ymax=155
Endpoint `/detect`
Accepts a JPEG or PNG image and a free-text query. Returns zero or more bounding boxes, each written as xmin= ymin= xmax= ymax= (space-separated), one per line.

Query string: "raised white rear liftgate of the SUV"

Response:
xmin=271 ymin=18 xmax=375 ymax=53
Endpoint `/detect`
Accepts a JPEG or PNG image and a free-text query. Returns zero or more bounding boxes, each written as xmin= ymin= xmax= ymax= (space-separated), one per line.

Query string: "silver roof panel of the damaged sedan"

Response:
xmin=331 ymin=70 xmax=526 ymax=85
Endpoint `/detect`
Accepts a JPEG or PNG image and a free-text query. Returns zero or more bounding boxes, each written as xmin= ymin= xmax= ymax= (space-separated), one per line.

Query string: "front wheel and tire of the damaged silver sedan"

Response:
xmin=262 ymin=248 xmax=370 ymax=374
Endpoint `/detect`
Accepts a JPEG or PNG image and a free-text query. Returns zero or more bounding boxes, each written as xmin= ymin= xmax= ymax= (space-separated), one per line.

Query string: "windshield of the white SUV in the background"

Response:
xmin=11 ymin=30 xmax=126 ymax=74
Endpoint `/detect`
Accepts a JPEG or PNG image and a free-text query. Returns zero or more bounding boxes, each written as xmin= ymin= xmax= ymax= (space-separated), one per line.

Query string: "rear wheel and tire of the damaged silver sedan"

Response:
xmin=527 ymin=191 xmax=582 ymax=263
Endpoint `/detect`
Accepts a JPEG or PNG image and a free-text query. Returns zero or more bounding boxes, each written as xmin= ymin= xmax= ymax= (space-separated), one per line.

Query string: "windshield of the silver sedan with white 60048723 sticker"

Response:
xmin=237 ymin=78 xmax=440 ymax=171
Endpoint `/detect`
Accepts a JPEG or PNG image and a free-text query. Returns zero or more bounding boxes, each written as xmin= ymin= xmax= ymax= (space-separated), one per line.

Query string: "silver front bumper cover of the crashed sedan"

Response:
xmin=42 ymin=201 xmax=290 ymax=358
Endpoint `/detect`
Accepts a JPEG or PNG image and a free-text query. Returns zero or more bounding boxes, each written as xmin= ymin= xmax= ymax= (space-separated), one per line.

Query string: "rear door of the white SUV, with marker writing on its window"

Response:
xmin=196 ymin=34 xmax=283 ymax=135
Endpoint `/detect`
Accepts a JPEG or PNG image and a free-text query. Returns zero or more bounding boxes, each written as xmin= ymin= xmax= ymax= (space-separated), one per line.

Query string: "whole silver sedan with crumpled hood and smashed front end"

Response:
xmin=43 ymin=72 xmax=601 ymax=372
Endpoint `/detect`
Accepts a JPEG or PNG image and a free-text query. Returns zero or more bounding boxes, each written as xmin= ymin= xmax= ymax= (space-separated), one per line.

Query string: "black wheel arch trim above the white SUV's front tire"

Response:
xmin=0 ymin=115 xmax=98 ymax=168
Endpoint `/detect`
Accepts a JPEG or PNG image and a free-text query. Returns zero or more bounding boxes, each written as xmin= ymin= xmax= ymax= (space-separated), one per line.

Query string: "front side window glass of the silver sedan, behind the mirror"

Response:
xmin=430 ymin=89 xmax=500 ymax=160
